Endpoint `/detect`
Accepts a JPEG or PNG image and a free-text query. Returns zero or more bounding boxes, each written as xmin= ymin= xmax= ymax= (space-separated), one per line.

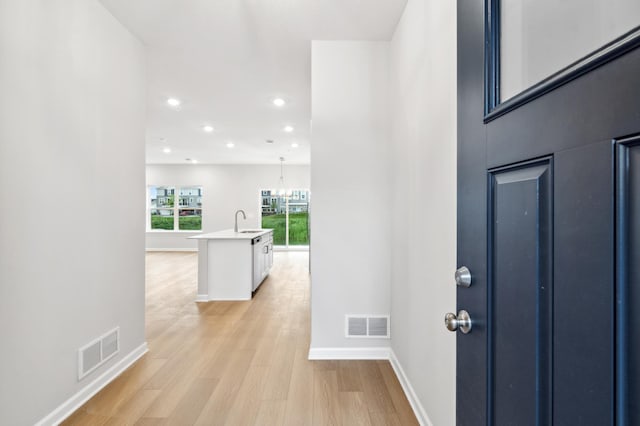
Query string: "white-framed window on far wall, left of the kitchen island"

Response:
xmin=147 ymin=186 xmax=202 ymax=231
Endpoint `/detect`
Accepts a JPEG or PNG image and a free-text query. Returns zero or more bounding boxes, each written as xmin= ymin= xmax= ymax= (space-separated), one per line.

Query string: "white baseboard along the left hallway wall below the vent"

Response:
xmin=36 ymin=342 xmax=149 ymax=426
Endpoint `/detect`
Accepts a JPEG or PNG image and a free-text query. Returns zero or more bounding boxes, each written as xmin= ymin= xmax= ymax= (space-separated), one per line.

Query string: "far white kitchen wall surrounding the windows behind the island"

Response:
xmin=146 ymin=163 xmax=313 ymax=250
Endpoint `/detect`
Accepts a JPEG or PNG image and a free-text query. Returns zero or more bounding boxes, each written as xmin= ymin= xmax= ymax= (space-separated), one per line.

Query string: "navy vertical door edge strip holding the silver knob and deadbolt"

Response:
xmin=456 ymin=0 xmax=487 ymax=426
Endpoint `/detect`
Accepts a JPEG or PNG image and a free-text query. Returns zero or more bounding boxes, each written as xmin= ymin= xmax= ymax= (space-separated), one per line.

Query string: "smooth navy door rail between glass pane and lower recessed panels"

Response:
xmin=486 ymin=50 xmax=640 ymax=167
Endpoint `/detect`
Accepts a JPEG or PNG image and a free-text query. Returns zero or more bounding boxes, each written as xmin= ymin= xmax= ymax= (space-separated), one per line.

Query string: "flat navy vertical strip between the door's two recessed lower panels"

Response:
xmin=554 ymin=140 xmax=615 ymax=425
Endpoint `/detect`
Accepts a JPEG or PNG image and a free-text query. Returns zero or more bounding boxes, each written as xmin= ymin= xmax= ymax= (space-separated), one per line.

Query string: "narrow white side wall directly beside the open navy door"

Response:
xmin=389 ymin=0 xmax=456 ymax=426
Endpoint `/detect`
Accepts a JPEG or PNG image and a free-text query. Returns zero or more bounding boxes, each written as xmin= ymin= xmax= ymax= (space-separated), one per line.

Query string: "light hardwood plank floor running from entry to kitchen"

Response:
xmin=64 ymin=252 xmax=418 ymax=426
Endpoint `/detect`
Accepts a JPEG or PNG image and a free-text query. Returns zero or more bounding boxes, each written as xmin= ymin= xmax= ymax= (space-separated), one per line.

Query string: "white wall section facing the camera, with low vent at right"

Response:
xmin=311 ymin=41 xmax=392 ymax=351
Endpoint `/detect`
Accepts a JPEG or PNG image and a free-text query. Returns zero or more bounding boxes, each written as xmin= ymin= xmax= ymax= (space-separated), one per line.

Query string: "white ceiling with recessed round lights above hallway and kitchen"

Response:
xmin=101 ymin=0 xmax=406 ymax=164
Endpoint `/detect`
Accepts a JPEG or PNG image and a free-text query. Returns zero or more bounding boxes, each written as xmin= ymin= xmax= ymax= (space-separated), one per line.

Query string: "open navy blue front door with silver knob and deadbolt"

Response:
xmin=457 ymin=0 xmax=640 ymax=426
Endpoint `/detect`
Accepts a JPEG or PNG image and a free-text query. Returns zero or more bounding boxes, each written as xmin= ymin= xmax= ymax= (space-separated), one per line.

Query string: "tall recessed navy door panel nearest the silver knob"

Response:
xmin=488 ymin=159 xmax=553 ymax=425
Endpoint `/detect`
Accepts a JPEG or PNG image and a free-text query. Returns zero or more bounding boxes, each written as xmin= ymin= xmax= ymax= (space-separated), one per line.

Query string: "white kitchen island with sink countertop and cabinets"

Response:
xmin=191 ymin=229 xmax=273 ymax=302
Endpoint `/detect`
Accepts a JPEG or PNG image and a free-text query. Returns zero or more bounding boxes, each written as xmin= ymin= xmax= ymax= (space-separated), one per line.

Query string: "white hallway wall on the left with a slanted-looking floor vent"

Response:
xmin=0 ymin=0 xmax=145 ymax=425
